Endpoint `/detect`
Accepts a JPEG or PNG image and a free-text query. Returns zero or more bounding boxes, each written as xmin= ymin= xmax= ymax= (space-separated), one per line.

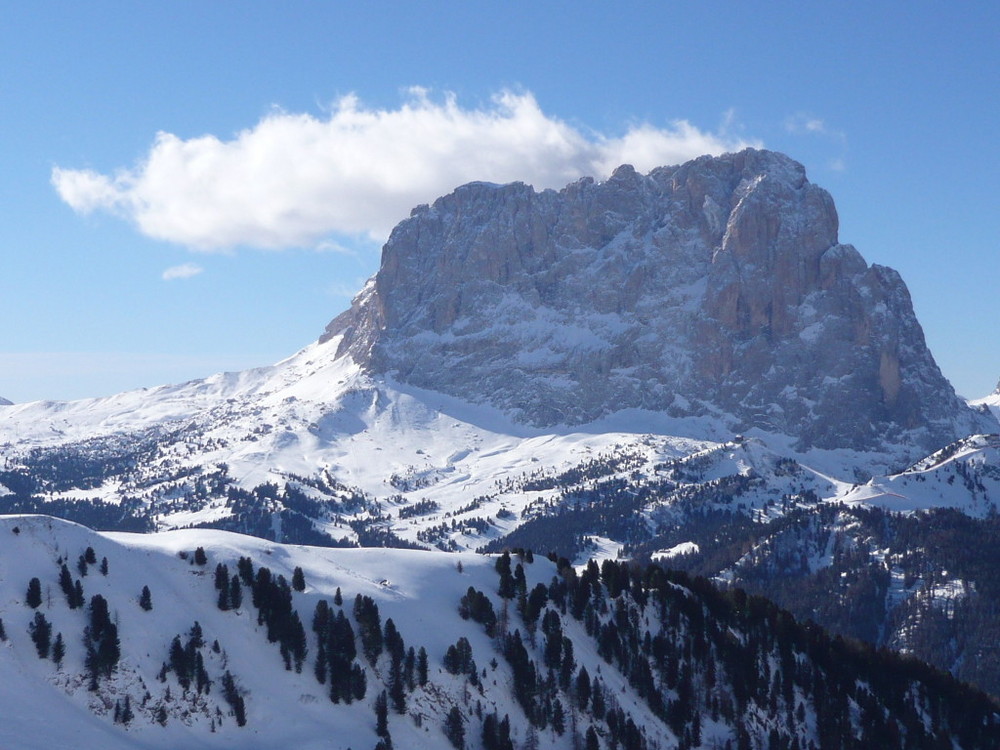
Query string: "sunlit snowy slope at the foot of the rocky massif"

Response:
xmin=0 ymin=328 xmax=928 ymax=554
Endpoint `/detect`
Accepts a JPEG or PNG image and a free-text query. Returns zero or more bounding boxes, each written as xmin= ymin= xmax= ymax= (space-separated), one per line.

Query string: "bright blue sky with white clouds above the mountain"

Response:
xmin=0 ymin=1 xmax=1000 ymax=401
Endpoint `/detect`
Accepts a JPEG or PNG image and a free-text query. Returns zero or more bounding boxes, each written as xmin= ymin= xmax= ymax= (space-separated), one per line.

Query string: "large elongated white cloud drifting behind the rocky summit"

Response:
xmin=52 ymin=89 xmax=759 ymax=250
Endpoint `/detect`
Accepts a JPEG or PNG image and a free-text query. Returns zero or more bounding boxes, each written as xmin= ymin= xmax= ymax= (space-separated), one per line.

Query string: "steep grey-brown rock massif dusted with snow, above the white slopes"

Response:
xmin=325 ymin=149 xmax=995 ymax=452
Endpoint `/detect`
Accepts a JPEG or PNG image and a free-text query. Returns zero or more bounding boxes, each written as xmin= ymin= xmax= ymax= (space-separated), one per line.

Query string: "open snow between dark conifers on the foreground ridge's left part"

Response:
xmin=0 ymin=516 xmax=600 ymax=750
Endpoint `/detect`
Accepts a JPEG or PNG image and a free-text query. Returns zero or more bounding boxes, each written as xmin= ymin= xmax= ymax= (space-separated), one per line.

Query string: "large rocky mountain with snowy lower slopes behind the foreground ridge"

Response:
xmin=0 ymin=145 xmax=1000 ymax=712
